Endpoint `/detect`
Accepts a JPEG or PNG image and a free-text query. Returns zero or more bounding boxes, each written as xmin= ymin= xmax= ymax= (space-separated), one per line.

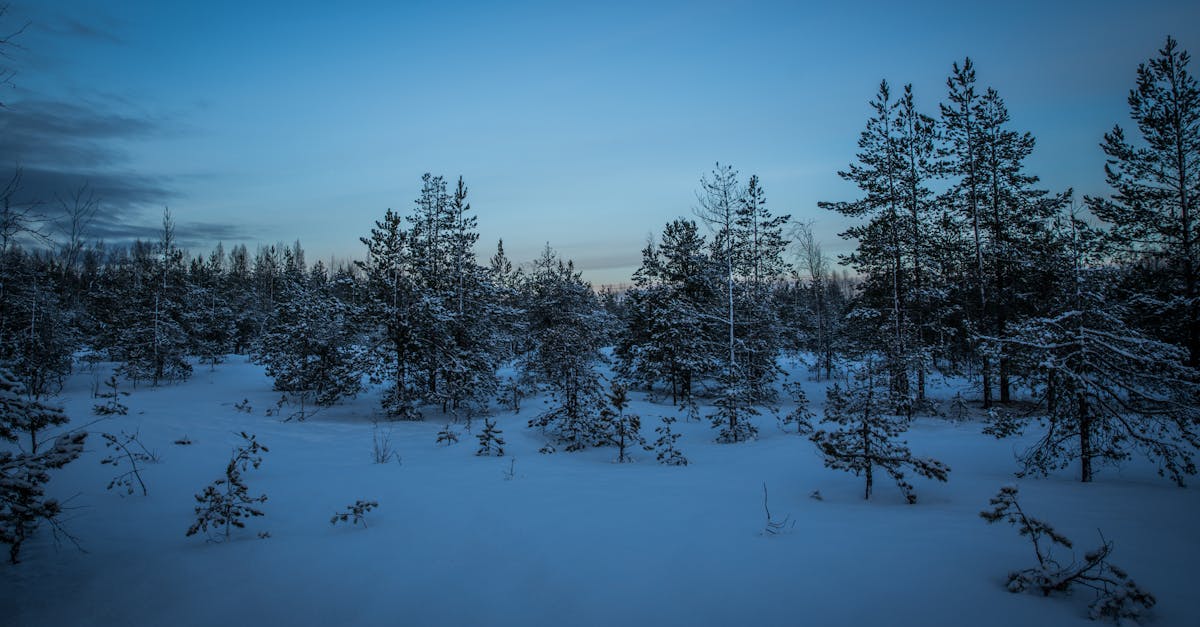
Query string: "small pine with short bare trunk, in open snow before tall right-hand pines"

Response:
xmin=812 ymin=358 xmax=950 ymax=503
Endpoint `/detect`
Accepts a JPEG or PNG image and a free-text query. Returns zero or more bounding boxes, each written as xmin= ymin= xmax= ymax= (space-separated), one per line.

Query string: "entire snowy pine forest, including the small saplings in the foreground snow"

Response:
xmin=0 ymin=13 xmax=1200 ymax=622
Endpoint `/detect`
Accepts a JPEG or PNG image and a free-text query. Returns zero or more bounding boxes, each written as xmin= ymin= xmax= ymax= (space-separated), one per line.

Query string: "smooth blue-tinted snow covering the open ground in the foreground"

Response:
xmin=0 ymin=357 xmax=1200 ymax=626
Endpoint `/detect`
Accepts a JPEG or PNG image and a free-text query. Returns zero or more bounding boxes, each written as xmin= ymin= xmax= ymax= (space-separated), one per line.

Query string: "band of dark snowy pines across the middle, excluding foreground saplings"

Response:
xmin=0 ymin=38 xmax=1200 ymax=482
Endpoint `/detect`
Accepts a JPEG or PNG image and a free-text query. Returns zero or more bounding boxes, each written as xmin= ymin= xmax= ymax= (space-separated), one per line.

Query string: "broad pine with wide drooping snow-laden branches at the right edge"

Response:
xmin=989 ymin=210 xmax=1200 ymax=485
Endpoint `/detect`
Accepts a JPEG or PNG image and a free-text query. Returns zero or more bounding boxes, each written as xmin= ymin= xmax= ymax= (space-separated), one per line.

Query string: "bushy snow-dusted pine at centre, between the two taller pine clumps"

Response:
xmin=520 ymin=244 xmax=607 ymax=450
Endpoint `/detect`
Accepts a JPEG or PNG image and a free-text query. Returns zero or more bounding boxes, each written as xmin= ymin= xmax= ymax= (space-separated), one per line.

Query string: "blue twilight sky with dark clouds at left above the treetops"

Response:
xmin=0 ymin=0 xmax=1200 ymax=283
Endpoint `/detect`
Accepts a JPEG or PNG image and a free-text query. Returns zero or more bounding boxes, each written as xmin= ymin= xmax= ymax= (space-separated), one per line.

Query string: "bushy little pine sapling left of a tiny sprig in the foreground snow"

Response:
xmin=186 ymin=431 xmax=269 ymax=542
